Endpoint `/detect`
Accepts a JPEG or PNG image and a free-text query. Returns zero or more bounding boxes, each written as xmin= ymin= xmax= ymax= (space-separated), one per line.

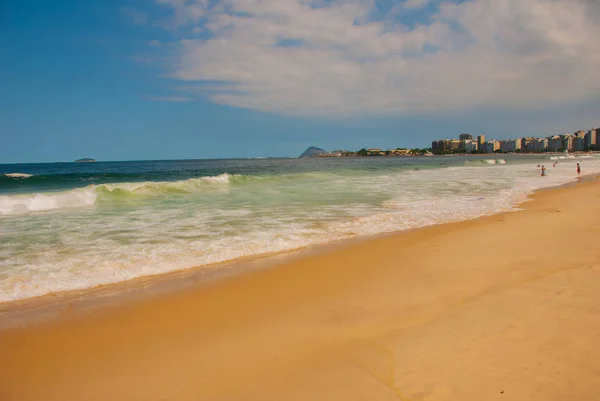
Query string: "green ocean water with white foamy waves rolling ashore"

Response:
xmin=0 ymin=156 xmax=600 ymax=302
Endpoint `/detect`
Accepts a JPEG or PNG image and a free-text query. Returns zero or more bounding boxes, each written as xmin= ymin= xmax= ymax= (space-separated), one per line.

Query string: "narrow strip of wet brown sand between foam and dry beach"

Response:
xmin=0 ymin=174 xmax=600 ymax=324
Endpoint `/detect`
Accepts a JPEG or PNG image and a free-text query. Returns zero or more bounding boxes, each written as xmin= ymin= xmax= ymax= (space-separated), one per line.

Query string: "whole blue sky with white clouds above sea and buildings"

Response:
xmin=0 ymin=0 xmax=600 ymax=163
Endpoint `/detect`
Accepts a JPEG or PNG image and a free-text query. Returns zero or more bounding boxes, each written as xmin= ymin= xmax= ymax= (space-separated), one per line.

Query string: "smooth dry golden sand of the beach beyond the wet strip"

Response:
xmin=0 ymin=181 xmax=600 ymax=401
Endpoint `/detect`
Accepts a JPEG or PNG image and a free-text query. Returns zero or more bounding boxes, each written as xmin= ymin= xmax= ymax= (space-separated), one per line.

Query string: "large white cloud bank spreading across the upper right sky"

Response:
xmin=144 ymin=0 xmax=600 ymax=116
